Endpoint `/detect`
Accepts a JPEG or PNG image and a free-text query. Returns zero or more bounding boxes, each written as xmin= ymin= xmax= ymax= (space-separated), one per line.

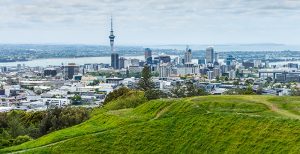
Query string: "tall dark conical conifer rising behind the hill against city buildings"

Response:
xmin=138 ymin=65 xmax=155 ymax=91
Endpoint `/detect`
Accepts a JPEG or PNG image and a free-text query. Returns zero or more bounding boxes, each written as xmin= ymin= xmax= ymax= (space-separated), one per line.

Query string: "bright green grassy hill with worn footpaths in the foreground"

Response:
xmin=0 ymin=92 xmax=300 ymax=153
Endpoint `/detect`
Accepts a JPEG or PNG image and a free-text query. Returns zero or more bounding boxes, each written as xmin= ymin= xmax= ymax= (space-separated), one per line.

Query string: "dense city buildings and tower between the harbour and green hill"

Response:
xmin=0 ymin=18 xmax=300 ymax=112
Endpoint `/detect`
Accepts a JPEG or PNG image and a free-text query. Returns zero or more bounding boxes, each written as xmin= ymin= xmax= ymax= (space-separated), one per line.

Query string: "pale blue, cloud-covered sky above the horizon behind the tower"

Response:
xmin=0 ymin=0 xmax=300 ymax=45
